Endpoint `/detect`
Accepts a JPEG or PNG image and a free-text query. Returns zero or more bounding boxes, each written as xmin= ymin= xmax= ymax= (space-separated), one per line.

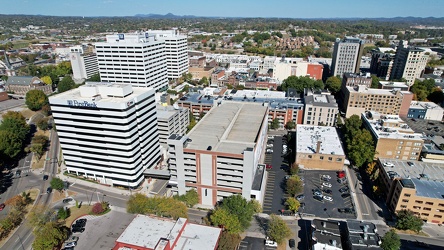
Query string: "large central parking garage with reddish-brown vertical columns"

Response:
xmin=167 ymin=102 xmax=268 ymax=206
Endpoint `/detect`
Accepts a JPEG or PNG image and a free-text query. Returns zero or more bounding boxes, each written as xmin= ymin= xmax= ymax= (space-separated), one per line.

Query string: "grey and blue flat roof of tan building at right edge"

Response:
xmin=379 ymin=158 xmax=444 ymax=199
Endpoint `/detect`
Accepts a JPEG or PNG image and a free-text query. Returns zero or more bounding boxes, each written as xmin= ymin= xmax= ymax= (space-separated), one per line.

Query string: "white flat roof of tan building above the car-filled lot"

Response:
xmin=296 ymin=124 xmax=345 ymax=156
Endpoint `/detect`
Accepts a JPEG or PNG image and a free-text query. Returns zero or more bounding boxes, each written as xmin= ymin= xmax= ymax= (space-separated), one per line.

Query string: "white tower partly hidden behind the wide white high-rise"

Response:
xmin=147 ymin=29 xmax=189 ymax=80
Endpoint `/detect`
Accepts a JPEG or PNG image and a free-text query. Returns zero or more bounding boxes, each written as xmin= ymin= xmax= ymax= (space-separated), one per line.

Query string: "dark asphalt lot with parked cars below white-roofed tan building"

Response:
xmin=299 ymin=170 xmax=356 ymax=219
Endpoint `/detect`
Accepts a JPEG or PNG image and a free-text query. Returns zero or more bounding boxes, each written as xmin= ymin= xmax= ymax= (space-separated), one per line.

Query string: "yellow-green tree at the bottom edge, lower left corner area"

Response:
xmin=32 ymin=222 xmax=69 ymax=250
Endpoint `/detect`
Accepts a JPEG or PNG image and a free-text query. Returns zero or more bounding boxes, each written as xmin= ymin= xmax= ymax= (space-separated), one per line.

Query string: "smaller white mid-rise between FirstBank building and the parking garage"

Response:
xmin=156 ymin=104 xmax=190 ymax=144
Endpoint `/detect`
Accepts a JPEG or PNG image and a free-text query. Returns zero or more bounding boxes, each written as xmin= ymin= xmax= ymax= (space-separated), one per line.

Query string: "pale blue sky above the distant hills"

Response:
xmin=0 ymin=0 xmax=444 ymax=18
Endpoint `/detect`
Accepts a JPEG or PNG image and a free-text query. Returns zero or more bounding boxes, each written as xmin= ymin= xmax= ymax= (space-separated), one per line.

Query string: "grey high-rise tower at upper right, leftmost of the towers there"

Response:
xmin=331 ymin=37 xmax=364 ymax=77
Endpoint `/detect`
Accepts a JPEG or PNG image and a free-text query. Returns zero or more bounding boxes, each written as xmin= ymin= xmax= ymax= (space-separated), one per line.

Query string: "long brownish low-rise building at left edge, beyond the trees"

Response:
xmin=5 ymin=76 xmax=52 ymax=96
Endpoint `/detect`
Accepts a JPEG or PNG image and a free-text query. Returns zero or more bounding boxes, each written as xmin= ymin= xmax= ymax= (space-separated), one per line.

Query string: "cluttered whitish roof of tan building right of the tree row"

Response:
xmin=361 ymin=112 xmax=424 ymax=141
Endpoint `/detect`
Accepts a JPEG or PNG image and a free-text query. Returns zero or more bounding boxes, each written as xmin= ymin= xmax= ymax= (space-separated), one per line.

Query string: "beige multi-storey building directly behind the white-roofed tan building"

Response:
xmin=304 ymin=89 xmax=339 ymax=126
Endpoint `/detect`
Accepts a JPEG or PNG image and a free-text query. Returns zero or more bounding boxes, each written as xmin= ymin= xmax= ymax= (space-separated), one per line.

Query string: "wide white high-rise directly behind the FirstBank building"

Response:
xmin=95 ymin=33 xmax=168 ymax=91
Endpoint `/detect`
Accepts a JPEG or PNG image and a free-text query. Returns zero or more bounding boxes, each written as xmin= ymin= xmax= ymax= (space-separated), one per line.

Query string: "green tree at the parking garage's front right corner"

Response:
xmin=220 ymin=194 xmax=254 ymax=231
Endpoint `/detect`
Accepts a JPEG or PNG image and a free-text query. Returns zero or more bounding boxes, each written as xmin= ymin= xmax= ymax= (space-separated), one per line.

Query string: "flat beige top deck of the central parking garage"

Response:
xmin=187 ymin=102 xmax=267 ymax=154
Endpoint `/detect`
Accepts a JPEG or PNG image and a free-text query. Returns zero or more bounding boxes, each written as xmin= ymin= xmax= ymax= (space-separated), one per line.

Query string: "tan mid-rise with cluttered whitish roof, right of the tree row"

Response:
xmin=361 ymin=111 xmax=424 ymax=160
